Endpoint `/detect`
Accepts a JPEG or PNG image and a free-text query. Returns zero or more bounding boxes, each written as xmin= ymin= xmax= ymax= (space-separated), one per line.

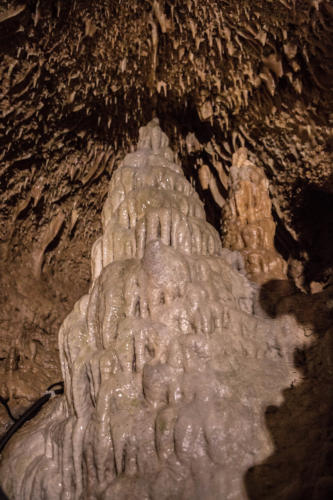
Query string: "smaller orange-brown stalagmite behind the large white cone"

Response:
xmin=222 ymin=148 xmax=286 ymax=283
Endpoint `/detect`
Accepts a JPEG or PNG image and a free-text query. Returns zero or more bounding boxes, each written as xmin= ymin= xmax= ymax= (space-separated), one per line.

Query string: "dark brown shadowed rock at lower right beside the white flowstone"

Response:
xmin=245 ymin=280 xmax=333 ymax=500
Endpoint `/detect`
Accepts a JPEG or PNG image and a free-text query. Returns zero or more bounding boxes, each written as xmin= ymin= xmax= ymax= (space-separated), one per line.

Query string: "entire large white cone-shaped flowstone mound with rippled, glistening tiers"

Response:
xmin=0 ymin=119 xmax=295 ymax=500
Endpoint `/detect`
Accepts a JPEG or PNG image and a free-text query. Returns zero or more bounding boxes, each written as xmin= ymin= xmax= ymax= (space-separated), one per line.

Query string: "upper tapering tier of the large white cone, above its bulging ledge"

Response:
xmin=92 ymin=119 xmax=221 ymax=278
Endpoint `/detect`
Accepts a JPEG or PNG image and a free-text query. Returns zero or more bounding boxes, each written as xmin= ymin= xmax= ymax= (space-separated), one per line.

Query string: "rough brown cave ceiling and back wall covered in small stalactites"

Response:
xmin=0 ymin=0 xmax=333 ymax=424
